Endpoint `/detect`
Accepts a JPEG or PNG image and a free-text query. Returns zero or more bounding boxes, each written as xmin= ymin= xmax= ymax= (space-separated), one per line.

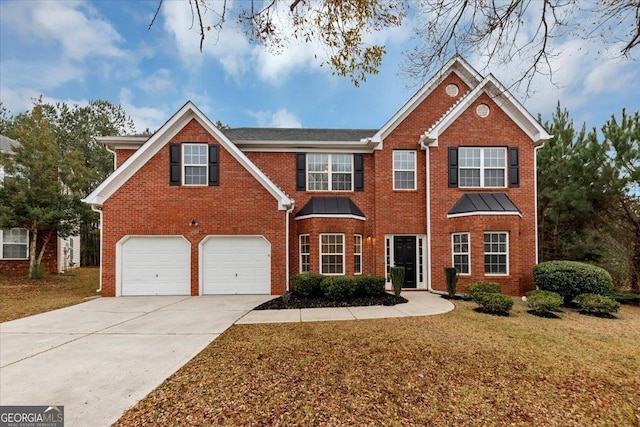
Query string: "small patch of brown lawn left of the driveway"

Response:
xmin=0 ymin=267 xmax=100 ymax=322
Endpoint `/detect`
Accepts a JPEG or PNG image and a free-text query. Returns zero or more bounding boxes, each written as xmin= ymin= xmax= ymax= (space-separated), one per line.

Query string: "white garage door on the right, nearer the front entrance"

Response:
xmin=200 ymin=236 xmax=271 ymax=295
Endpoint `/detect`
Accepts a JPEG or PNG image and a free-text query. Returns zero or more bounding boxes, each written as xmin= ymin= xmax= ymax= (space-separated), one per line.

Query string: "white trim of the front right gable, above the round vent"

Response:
xmin=420 ymin=74 xmax=551 ymax=147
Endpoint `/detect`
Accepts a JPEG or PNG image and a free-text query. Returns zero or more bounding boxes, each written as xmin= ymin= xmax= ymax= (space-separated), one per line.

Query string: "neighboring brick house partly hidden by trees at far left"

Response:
xmin=0 ymin=135 xmax=80 ymax=274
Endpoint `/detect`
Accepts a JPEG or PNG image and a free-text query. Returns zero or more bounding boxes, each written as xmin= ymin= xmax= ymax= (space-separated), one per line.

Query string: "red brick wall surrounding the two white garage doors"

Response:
xmin=102 ymin=120 xmax=285 ymax=296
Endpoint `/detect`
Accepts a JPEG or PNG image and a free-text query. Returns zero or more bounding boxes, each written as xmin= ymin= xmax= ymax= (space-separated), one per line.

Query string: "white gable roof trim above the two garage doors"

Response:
xmin=84 ymin=101 xmax=293 ymax=210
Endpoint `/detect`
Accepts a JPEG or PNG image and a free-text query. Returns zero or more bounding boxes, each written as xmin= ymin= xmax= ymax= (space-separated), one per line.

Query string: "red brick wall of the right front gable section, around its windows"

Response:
xmin=430 ymin=95 xmax=536 ymax=295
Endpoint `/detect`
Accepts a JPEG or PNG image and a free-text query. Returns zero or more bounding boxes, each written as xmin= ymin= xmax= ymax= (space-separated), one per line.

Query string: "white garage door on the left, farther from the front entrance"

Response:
xmin=120 ymin=236 xmax=191 ymax=295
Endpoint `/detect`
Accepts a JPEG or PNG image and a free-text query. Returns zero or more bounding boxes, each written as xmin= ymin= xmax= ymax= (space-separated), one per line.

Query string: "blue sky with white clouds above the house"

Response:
xmin=0 ymin=0 xmax=640 ymax=131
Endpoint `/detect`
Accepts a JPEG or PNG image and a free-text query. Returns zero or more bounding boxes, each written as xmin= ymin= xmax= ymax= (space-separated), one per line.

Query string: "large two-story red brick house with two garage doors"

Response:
xmin=85 ymin=57 xmax=550 ymax=296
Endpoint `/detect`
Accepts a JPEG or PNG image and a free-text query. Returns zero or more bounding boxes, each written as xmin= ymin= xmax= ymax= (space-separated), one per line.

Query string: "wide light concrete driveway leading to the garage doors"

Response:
xmin=0 ymin=295 xmax=272 ymax=427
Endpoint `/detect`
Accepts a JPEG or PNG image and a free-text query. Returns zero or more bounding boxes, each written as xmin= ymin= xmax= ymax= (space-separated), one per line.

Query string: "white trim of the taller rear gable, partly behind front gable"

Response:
xmin=371 ymin=55 xmax=482 ymax=149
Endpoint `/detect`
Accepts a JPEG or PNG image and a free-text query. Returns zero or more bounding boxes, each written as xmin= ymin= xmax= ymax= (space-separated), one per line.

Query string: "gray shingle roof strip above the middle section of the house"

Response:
xmin=222 ymin=128 xmax=378 ymax=142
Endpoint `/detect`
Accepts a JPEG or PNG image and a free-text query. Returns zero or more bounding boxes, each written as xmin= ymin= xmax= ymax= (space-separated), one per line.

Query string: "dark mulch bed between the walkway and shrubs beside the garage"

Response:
xmin=254 ymin=293 xmax=408 ymax=310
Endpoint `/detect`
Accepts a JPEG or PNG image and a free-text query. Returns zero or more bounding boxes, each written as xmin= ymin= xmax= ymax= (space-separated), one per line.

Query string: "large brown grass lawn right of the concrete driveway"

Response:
xmin=115 ymin=300 xmax=640 ymax=427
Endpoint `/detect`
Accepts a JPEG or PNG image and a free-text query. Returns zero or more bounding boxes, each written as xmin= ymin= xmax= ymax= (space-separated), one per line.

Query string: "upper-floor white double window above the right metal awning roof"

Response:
xmin=458 ymin=147 xmax=507 ymax=188
